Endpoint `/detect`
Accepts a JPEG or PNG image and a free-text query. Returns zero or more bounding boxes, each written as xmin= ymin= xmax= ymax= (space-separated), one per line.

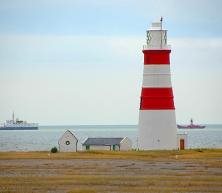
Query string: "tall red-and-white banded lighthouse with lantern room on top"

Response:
xmin=138 ymin=18 xmax=177 ymax=150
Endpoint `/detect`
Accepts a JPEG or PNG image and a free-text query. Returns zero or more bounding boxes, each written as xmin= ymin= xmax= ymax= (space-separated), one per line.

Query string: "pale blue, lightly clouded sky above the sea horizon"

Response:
xmin=0 ymin=0 xmax=222 ymax=125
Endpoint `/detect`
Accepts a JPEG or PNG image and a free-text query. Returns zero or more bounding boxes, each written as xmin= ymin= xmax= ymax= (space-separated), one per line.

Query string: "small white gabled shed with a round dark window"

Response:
xmin=58 ymin=130 xmax=78 ymax=152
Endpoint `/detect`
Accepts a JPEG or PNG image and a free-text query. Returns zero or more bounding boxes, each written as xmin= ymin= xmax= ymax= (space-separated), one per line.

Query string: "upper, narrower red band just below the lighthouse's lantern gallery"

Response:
xmin=143 ymin=50 xmax=171 ymax=65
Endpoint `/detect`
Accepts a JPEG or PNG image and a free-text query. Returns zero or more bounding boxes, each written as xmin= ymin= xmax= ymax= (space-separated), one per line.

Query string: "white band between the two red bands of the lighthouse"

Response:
xmin=143 ymin=65 xmax=171 ymax=88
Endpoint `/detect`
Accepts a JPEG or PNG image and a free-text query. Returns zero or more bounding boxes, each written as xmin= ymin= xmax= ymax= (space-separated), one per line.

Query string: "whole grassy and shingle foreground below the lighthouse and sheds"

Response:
xmin=0 ymin=149 xmax=222 ymax=193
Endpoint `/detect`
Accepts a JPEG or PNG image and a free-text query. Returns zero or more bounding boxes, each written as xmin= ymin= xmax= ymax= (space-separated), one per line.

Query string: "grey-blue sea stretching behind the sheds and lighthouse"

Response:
xmin=0 ymin=124 xmax=222 ymax=152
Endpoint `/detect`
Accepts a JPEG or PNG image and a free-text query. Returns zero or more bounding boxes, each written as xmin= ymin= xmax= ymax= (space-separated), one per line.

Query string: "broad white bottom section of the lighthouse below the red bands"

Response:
xmin=138 ymin=110 xmax=177 ymax=150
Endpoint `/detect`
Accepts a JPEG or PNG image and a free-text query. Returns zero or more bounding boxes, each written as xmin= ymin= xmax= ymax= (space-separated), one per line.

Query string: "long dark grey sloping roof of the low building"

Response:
xmin=83 ymin=138 xmax=123 ymax=145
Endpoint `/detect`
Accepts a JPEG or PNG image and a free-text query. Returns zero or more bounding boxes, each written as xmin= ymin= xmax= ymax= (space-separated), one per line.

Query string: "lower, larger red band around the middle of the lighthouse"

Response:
xmin=140 ymin=88 xmax=175 ymax=110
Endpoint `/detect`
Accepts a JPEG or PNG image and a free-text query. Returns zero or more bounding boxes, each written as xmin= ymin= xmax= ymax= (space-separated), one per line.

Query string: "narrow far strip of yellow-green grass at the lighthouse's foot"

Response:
xmin=0 ymin=149 xmax=222 ymax=160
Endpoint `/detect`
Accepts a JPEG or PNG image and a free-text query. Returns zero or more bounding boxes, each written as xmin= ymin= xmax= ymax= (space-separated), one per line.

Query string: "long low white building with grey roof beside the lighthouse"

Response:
xmin=82 ymin=137 xmax=132 ymax=151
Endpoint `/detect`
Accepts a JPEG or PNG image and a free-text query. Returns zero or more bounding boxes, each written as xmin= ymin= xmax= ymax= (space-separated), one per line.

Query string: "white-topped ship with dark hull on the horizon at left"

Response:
xmin=0 ymin=113 xmax=39 ymax=130
